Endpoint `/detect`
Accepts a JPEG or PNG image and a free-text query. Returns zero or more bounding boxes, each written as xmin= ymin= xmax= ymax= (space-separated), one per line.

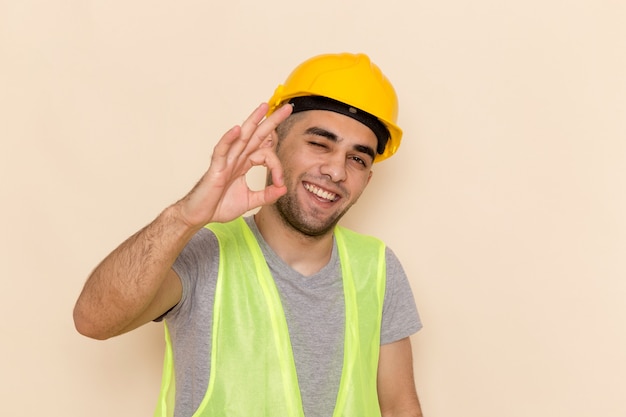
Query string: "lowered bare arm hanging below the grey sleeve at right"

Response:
xmin=378 ymin=337 xmax=422 ymax=417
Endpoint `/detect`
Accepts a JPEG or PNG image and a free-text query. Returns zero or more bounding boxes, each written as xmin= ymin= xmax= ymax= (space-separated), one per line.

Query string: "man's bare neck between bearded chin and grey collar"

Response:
xmin=254 ymin=206 xmax=333 ymax=276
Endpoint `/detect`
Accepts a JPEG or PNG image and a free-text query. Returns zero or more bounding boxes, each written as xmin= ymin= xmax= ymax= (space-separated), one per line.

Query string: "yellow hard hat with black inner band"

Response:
xmin=267 ymin=53 xmax=402 ymax=162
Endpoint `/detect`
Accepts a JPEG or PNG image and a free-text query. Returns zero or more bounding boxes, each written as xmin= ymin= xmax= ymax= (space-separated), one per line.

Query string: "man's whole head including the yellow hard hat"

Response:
xmin=262 ymin=54 xmax=402 ymax=236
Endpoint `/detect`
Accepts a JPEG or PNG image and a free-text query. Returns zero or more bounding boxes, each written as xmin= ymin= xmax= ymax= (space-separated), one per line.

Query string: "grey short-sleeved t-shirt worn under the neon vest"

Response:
xmin=165 ymin=217 xmax=422 ymax=417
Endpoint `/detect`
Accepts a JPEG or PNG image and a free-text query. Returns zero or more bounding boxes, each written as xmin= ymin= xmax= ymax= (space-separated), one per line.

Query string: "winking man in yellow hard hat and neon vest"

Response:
xmin=74 ymin=54 xmax=421 ymax=417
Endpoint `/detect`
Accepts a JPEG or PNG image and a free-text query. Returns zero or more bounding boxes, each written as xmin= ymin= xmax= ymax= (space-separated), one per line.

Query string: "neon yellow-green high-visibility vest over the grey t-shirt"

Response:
xmin=154 ymin=218 xmax=386 ymax=417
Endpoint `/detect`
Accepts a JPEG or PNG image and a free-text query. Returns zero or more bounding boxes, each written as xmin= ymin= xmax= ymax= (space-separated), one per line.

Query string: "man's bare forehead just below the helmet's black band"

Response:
xmin=290 ymin=110 xmax=378 ymax=149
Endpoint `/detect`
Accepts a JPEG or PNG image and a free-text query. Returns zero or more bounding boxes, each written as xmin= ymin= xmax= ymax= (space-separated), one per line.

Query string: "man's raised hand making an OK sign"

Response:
xmin=177 ymin=103 xmax=292 ymax=227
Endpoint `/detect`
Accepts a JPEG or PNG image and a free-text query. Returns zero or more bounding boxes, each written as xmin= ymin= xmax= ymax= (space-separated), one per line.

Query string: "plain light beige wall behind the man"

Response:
xmin=0 ymin=0 xmax=626 ymax=417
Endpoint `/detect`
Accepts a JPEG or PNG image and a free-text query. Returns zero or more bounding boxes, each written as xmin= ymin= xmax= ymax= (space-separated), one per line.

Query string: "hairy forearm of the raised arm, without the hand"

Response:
xmin=74 ymin=205 xmax=197 ymax=339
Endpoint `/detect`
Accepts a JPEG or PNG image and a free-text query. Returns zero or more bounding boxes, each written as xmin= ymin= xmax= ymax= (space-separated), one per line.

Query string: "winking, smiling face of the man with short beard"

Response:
xmin=275 ymin=110 xmax=377 ymax=236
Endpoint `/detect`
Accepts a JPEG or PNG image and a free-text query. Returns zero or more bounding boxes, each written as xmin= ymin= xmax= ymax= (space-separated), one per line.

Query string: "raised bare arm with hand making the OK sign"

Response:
xmin=74 ymin=104 xmax=291 ymax=339
